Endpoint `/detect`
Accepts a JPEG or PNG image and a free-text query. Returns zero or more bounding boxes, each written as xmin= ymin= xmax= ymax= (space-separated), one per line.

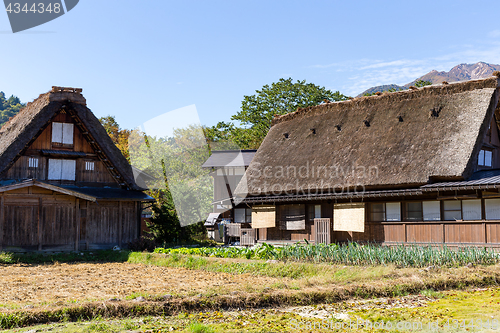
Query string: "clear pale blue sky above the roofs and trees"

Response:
xmin=0 ymin=0 xmax=500 ymax=134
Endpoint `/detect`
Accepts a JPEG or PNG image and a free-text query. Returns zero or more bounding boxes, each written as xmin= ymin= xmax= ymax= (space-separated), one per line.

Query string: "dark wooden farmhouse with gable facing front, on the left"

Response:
xmin=0 ymin=87 xmax=152 ymax=251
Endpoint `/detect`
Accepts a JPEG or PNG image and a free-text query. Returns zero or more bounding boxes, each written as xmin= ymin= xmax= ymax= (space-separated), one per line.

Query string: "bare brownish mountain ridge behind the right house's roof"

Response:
xmin=358 ymin=61 xmax=500 ymax=96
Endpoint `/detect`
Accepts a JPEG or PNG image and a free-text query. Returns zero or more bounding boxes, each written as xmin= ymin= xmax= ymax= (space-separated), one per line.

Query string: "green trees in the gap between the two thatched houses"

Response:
xmin=129 ymin=125 xmax=213 ymax=243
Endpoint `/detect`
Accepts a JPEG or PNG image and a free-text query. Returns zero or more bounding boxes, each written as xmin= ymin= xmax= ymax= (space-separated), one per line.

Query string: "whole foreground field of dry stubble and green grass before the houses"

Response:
xmin=0 ymin=253 xmax=500 ymax=332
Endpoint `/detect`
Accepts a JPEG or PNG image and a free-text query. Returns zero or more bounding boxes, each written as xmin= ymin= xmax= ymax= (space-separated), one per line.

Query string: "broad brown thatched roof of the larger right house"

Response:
xmin=236 ymin=77 xmax=499 ymax=195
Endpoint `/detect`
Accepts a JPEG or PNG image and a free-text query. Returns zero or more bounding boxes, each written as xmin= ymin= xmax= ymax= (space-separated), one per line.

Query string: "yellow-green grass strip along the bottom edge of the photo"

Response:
xmin=7 ymin=288 xmax=500 ymax=333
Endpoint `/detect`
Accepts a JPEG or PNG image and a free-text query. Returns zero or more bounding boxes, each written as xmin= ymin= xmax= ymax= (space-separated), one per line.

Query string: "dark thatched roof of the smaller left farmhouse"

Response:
xmin=0 ymin=87 xmax=141 ymax=190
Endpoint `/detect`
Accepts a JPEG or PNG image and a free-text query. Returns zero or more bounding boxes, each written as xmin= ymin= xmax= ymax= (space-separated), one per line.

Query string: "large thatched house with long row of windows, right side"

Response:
xmin=226 ymin=73 xmax=500 ymax=246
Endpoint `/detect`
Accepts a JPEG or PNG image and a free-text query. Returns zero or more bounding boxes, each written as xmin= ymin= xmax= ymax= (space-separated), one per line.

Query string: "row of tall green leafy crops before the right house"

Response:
xmin=155 ymin=243 xmax=500 ymax=267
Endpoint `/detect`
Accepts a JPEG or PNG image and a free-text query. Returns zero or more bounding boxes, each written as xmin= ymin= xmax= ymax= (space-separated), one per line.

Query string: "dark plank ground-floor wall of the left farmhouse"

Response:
xmin=0 ymin=187 xmax=140 ymax=252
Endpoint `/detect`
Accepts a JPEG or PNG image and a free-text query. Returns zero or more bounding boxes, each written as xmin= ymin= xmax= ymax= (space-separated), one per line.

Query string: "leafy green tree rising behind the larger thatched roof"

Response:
xmin=205 ymin=78 xmax=348 ymax=149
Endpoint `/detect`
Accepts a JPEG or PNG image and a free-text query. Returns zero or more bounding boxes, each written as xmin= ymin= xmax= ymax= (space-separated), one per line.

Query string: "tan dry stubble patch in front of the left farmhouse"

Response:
xmin=0 ymin=263 xmax=283 ymax=310
